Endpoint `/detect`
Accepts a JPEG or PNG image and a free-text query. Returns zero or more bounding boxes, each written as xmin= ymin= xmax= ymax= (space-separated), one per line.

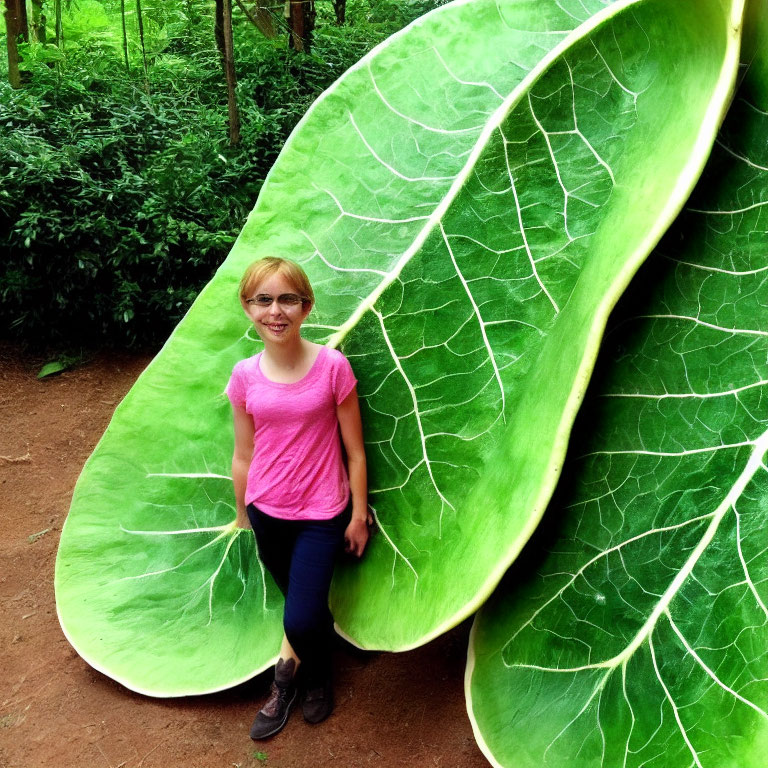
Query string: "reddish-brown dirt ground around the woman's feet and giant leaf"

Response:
xmin=0 ymin=344 xmax=488 ymax=768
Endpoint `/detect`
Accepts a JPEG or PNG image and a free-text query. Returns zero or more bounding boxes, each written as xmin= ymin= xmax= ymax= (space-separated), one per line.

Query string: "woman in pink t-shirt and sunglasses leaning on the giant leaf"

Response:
xmin=227 ymin=257 xmax=369 ymax=739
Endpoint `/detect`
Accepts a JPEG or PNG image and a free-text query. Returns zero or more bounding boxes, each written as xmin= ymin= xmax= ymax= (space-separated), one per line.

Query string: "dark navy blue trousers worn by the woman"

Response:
xmin=246 ymin=504 xmax=351 ymax=686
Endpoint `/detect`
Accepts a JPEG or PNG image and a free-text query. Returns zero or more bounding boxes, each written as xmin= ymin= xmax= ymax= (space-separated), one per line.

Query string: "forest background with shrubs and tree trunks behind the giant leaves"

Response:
xmin=0 ymin=0 xmax=445 ymax=359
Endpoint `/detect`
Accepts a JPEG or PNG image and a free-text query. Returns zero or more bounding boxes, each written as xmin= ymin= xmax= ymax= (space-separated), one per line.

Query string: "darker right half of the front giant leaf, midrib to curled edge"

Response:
xmin=332 ymin=2 xmax=741 ymax=649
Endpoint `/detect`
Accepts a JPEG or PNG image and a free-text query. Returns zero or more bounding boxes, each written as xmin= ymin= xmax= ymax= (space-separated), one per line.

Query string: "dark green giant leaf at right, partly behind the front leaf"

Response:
xmin=467 ymin=39 xmax=768 ymax=768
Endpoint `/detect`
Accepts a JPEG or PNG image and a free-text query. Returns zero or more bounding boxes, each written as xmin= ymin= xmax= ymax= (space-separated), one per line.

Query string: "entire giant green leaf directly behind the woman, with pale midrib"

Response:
xmin=56 ymin=0 xmax=740 ymax=695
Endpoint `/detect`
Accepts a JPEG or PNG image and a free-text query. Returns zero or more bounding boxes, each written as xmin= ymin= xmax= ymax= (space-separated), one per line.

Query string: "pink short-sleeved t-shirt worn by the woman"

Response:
xmin=226 ymin=347 xmax=357 ymax=520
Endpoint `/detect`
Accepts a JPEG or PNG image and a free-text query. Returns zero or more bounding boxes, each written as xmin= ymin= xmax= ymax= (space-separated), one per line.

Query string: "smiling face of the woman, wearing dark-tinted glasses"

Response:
xmin=245 ymin=272 xmax=312 ymax=345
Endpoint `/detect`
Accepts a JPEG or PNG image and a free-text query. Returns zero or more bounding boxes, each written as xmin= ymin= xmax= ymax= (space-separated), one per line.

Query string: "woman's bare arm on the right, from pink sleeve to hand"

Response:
xmin=336 ymin=387 xmax=368 ymax=557
